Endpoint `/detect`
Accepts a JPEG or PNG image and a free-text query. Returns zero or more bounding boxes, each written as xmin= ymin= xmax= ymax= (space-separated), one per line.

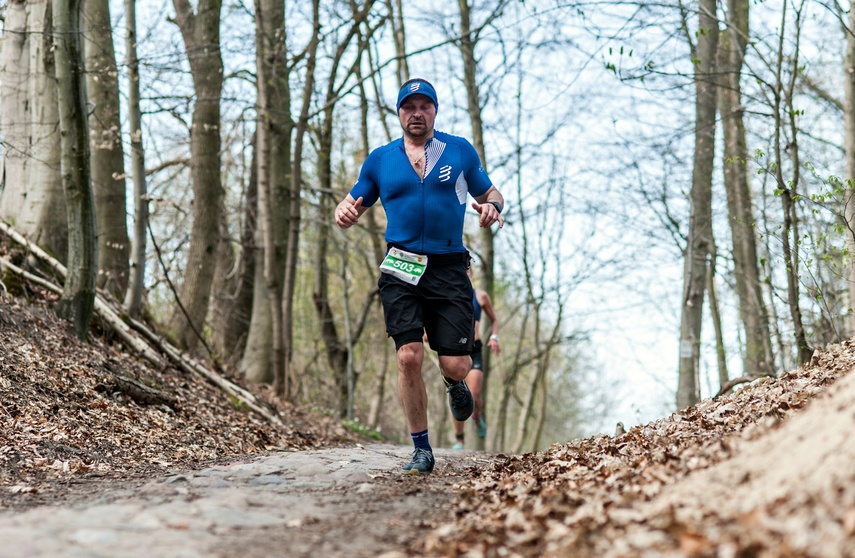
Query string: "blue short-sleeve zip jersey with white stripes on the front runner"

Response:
xmin=350 ymin=132 xmax=492 ymax=254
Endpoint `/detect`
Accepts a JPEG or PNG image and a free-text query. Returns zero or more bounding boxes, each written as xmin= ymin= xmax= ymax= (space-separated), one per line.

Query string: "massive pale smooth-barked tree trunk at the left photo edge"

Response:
xmin=0 ymin=0 xmax=68 ymax=263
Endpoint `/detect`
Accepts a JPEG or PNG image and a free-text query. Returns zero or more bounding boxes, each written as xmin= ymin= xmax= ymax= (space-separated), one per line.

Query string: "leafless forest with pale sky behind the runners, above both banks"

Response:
xmin=0 ymin=0 xmax=855 ymax=452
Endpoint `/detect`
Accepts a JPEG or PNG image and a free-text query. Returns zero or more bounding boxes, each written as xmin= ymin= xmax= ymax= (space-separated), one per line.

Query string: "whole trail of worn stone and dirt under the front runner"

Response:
xmin=0 ymin=444 xmax=490 ymax=558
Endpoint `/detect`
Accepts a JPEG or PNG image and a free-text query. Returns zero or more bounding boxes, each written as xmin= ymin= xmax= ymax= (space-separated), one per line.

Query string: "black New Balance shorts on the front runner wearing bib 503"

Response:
xmin=377 ymin=252 xmax=475 ymax=356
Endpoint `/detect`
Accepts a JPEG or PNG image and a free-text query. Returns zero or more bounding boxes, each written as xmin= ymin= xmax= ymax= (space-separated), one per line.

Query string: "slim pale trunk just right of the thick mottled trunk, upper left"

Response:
xmin=125 ymin=0 xmax=148 ymax=319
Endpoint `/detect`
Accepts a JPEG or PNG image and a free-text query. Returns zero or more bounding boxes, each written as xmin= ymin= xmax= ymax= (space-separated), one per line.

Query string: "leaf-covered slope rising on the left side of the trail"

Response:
xmin=0 ymin=293 xmax=354 ymax=507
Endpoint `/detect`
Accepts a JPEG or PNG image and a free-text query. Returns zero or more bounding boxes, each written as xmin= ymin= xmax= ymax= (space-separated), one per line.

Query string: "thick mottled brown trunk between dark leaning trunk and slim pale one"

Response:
xmin=83 ymin=0 xmax=130 ymax=300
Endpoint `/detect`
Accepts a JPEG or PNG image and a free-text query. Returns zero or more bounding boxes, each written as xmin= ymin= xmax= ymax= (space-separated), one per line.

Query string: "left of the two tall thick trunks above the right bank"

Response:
xmin=677 ymin=0 xmax=718 ymax=409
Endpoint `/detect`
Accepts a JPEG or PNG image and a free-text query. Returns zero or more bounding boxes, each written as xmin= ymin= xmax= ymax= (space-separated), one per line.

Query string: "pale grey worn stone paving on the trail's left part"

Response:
xmin=0 ymin=444 xmax=468 ymax=558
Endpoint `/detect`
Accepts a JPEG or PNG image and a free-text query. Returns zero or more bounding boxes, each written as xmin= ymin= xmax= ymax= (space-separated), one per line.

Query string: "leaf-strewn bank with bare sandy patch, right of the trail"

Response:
xmin=420 ymin=341 xmax=855 ymax=557
